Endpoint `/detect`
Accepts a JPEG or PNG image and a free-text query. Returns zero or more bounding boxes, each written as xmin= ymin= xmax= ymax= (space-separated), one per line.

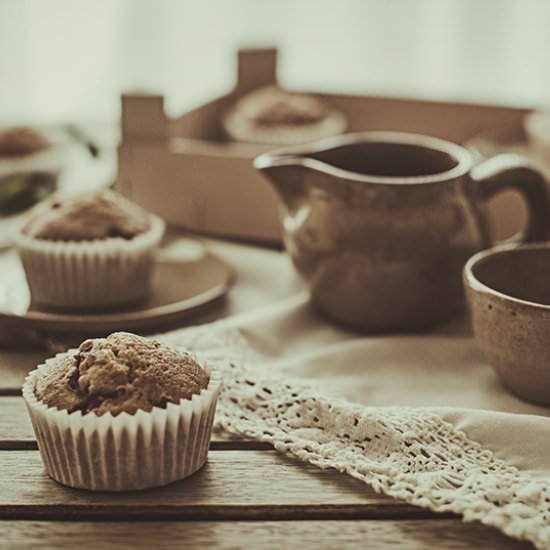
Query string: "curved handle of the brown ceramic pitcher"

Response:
xmin=470 ymin=154 xmax=550 ymax=242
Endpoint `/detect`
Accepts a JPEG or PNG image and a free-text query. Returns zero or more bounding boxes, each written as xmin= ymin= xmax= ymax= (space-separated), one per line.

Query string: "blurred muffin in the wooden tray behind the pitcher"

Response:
xmin=222 ymin=86 xmax=346 ymax=145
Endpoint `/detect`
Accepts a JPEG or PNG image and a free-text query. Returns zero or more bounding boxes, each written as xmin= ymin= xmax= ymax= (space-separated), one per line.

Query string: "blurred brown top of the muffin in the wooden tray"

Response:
xmin=235 ymin=86 xmax=329 ymax=126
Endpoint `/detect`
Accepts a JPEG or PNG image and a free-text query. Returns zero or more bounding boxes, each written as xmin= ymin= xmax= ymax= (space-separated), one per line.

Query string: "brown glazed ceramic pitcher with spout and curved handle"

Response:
xmin=255 ymin=132 xmax=550 ymax=331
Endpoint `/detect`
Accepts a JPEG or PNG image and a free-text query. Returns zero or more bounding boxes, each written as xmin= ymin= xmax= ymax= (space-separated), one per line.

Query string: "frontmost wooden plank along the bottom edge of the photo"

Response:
xmin=0 ymin=519 xmax=532 ymax=550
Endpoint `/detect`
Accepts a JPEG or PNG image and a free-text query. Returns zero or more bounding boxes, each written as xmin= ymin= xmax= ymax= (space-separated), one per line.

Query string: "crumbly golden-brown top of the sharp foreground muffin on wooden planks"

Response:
xmin=34 ymin=332 xmax=210 ymax=416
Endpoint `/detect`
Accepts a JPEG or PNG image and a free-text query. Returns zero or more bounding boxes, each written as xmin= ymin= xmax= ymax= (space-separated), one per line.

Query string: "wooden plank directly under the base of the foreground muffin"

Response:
xmin=0 ymin=451 xmax=433 ymax=520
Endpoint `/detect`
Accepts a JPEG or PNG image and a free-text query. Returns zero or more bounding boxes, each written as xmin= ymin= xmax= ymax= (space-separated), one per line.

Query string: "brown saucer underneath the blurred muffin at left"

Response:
xmin=0 ymin=239 xmax=235 ymax=336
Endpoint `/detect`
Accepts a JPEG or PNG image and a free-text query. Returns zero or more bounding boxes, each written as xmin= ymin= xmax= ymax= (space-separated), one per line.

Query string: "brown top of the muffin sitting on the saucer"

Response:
xmin=23 ymin=190 xmax=151 ymax=241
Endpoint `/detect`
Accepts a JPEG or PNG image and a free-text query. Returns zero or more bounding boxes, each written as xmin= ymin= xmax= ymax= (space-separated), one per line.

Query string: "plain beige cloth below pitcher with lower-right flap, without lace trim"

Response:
xmin=191 ymin=293 xmax=550 ymax=476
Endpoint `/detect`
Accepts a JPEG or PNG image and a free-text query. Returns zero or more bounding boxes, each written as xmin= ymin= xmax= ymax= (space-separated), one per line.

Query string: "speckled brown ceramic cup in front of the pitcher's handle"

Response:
xmin=464 ymin=244 xmax=550 ymax=405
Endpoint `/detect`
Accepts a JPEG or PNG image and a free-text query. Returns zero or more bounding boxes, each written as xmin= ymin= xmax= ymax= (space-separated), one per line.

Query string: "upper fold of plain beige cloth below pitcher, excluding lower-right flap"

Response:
xmin=236 ymin=294 xmax=550 ymax=410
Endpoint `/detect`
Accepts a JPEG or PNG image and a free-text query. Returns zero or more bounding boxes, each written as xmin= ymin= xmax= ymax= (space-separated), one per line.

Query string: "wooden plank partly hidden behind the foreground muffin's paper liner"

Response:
xmin=0 ymin=396 xmax=273 ymax=451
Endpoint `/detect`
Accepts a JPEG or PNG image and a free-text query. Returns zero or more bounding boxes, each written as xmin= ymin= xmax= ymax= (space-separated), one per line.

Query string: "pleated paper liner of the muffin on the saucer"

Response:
xmin=15 ymin=215 xmax=165 ymax=309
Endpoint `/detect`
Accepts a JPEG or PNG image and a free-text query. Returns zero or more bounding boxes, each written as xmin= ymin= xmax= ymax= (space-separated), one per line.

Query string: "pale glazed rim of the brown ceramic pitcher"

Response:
xmin=254 ymin=130 xmax=474 ymax=185
